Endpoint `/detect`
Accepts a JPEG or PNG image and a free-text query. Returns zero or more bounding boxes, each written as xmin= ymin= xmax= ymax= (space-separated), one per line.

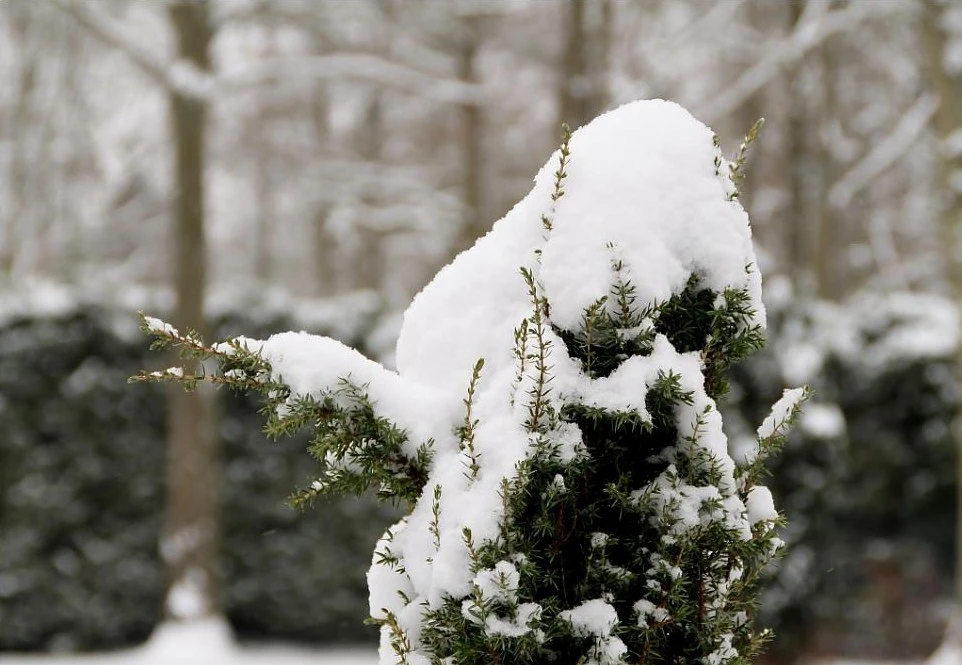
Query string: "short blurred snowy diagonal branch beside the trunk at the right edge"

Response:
xmin=828 ymin=92 xmax=939 ymax=208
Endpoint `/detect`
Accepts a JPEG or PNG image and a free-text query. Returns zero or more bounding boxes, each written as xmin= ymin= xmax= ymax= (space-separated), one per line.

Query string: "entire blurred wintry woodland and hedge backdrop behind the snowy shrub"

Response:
xmin=0 ymin=0 xmax=962 ymax=663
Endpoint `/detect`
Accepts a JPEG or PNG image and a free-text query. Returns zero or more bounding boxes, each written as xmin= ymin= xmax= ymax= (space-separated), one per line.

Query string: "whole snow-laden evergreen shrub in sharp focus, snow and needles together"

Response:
xmin=139 ymin=100 xmax=804 ymax=665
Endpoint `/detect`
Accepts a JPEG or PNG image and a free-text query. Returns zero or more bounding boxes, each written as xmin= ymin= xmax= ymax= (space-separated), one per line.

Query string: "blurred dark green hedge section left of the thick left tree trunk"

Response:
xmin=0 ymin=312 xmax=164 ymax=650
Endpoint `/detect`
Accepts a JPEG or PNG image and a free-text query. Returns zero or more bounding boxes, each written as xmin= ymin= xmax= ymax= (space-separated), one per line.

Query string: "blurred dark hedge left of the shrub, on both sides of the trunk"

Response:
xmin=0 ymin=309 xmax=396 ymax=651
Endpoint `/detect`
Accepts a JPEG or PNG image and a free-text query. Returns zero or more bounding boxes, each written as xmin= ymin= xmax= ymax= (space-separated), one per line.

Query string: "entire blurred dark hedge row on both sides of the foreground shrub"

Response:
xmin=0 ymin=296 xmax=958 ymax=662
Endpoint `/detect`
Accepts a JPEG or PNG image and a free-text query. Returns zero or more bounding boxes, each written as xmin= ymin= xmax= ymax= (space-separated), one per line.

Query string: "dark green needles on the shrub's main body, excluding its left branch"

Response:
xmin=412 ymin=264 xmax=771 ymax=665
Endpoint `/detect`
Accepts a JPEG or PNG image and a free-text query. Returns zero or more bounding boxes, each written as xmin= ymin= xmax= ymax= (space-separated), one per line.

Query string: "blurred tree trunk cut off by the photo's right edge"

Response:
xmin=923 ymin=0 xmax=962 ymax=662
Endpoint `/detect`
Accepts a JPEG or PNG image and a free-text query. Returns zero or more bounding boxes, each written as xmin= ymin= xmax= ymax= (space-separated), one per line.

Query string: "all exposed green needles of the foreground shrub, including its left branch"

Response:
xmin=139 ymin=266 xmax=779 ymax=665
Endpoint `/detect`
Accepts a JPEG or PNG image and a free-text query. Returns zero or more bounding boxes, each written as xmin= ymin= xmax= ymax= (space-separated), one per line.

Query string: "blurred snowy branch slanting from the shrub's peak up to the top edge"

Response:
xmin=700 ymin=2 xmax=905 ymax=121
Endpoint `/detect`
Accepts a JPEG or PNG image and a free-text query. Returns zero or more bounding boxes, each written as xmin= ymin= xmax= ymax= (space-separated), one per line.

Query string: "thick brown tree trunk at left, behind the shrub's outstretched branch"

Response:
xmin=161 ymin=0 xmax=220 ymax=620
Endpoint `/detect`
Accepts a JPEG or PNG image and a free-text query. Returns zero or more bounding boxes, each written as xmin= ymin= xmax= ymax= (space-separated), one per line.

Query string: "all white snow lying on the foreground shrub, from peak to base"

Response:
xmin=236 ymin=100 xmax=765 ymax=665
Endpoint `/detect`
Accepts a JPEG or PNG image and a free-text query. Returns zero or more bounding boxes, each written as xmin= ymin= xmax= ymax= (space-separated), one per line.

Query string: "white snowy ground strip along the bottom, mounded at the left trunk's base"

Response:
xmin=0 ymin=621 xmax=377 ymax=665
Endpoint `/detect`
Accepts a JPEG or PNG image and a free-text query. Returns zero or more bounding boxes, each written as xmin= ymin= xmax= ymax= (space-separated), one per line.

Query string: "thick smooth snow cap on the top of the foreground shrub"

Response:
xmin=397 ymin=100 xmax=764 ymax=390
